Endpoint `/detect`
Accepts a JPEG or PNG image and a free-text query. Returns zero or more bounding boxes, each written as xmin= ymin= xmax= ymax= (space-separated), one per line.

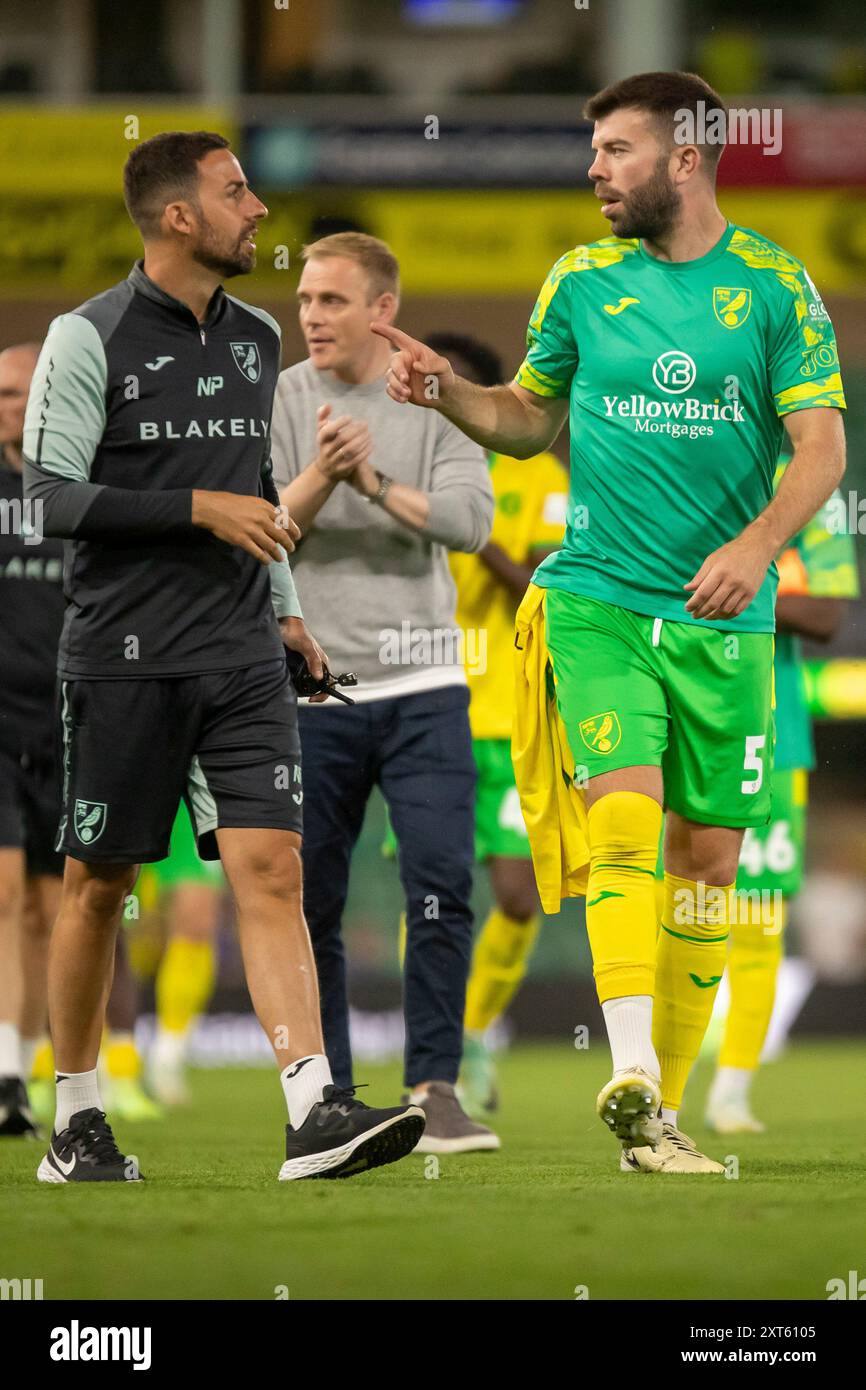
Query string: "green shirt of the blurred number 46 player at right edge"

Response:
xmin=773 ymin=457 xmax=860 ymax=769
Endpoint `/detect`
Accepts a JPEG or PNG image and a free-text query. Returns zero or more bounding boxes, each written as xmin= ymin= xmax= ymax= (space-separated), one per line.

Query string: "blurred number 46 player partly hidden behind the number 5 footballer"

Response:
xmin=706 ymin=456 xmax=859 ymax=1134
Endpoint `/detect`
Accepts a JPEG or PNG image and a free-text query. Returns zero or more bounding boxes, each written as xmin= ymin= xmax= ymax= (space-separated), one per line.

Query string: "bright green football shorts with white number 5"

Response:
xmin=545 ymin=589 xmax=773 ymax=826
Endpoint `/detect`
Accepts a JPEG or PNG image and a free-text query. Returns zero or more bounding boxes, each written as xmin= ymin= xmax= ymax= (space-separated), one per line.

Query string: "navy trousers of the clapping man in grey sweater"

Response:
xmin=299 ymin=685 xmax=475 ymax=1086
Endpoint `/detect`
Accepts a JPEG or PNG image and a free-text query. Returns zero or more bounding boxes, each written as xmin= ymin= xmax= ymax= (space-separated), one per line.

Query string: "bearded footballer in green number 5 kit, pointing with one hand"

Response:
xmin=375 ymin=72 xmax=845 ymax=1173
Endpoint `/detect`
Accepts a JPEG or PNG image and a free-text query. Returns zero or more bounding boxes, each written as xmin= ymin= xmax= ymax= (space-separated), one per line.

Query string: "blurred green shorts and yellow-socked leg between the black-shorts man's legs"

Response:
xmin=147 ymin=806 xmax=225 ymax=1105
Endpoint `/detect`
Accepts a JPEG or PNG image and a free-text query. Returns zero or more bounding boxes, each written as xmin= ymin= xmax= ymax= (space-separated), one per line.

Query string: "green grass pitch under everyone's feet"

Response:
xmin=0 ymin=1043 xmax=866 ymax=1300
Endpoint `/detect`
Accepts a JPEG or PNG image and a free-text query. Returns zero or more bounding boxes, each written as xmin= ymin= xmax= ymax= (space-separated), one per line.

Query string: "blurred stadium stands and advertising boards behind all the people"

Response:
xmin=0 ymin=0 xmax=866 ymax=1063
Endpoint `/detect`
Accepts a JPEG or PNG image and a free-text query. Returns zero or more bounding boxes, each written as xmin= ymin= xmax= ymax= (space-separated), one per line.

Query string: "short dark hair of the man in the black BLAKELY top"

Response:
xmin=124 ymin=131 xmax=228 ymax=238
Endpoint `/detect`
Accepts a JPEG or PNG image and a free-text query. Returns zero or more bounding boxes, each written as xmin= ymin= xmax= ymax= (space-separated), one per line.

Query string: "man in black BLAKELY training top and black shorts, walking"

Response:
xmin=24 ymin=132 xmax=423 ymax=1182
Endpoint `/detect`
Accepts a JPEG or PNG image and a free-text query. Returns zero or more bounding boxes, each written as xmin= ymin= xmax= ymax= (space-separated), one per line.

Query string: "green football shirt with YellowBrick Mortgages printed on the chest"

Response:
xmin=517 ymin=225 xmax=845 ymax=632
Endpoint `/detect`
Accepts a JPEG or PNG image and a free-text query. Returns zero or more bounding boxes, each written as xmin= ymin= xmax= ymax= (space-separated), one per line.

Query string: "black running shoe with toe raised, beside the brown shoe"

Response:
xmin=279 ymin=1086 xmax=424 ymax=1183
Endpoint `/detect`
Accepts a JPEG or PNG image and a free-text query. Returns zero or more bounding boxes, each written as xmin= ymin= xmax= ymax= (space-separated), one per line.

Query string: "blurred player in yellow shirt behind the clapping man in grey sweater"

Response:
xmin=427 ymin=332 xmax=569 ymax=1112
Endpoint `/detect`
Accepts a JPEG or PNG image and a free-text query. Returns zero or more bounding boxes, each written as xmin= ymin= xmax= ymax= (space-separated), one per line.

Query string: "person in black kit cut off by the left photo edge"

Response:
xmin=0 ymin=343 xmax=58 ymax=1136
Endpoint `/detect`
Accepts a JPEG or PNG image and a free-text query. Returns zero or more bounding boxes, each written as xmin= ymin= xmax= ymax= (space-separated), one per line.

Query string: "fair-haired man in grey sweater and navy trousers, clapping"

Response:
xmin=272 ymin=232 xmax=499 ymax=1154
